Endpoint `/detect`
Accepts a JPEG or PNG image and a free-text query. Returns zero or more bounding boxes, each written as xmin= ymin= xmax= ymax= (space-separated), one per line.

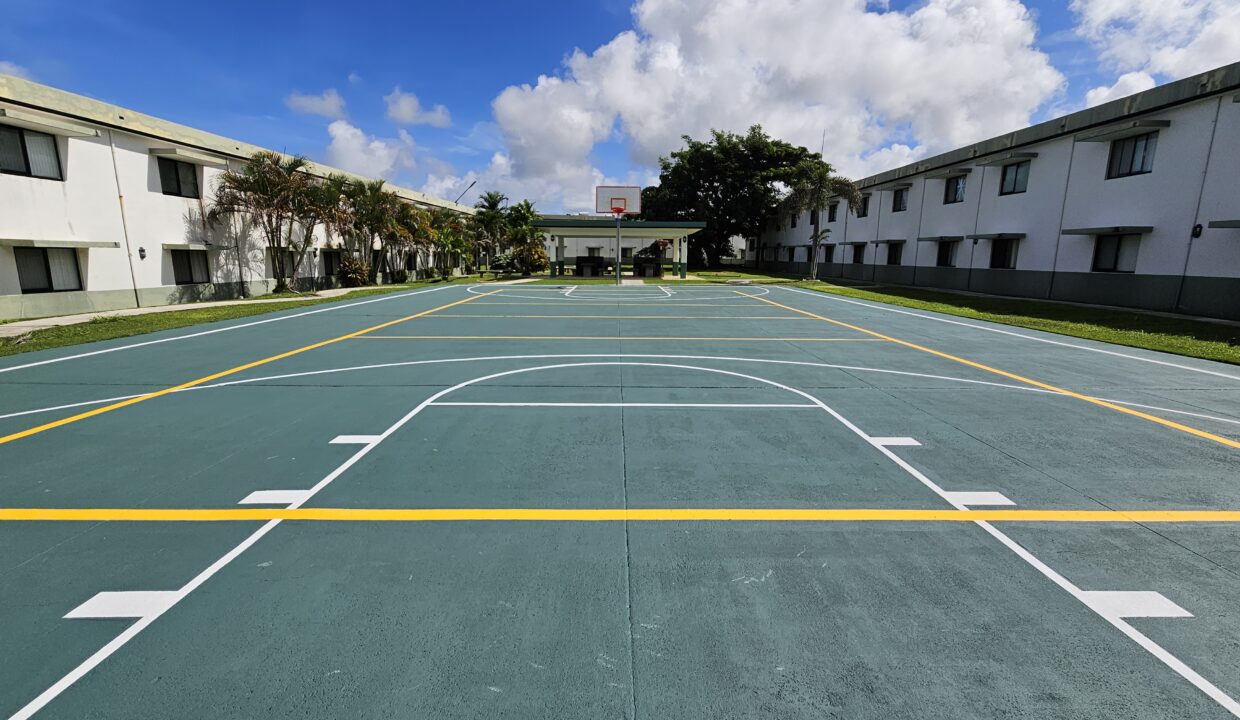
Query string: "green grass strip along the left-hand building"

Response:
xmin=0 ymin=279 xmax=461 ymax=357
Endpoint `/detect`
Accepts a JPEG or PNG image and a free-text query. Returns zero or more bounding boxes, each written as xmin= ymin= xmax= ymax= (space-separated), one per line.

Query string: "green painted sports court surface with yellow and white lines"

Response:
xmin=0 ymin=285 xmax=1240 ymax=719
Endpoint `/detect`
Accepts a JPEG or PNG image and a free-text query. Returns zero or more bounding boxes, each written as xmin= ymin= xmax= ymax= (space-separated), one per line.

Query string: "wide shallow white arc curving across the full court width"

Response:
xmin=0 ymin=353 xmax=1240 ymax=425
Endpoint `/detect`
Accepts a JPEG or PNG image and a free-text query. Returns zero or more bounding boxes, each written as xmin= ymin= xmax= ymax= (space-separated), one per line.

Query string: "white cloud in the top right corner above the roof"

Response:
xmin=1071 ymin=0 xmax=1240 ymax=99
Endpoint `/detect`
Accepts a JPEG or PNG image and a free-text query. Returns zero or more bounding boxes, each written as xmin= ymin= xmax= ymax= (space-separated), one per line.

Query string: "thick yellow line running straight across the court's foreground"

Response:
xmin=7 ymin=508 xmax=1240 ymax=523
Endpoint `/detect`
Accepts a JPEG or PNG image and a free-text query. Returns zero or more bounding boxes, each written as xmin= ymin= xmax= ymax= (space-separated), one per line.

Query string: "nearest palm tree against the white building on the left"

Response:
xmin=207 ymin=150 xmax=309 ymax=292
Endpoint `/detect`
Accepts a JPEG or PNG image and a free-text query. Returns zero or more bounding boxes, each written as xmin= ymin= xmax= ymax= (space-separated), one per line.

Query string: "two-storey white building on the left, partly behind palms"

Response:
xmin=0 ymin=74 xmax=472 ymax=318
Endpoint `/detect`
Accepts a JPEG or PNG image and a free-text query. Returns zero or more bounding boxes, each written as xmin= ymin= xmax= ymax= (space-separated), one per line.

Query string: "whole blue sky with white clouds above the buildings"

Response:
xmin=0 ymin=0 xmax=1240 ymax=209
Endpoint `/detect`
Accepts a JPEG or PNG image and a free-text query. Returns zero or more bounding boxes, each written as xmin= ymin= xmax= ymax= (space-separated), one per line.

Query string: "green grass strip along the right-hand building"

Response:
xmin=693 ymin=270 xmax=1240 ymax=364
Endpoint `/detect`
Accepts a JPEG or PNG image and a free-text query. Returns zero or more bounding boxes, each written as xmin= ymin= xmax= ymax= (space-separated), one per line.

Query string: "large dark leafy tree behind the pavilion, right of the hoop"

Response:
xmin=641 ymin=125 xmax=817 ymax=265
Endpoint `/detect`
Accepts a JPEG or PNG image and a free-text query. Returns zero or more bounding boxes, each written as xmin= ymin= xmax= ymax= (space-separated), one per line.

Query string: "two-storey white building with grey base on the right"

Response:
xmin=746 ymin=63 xmax=1240 ymax=320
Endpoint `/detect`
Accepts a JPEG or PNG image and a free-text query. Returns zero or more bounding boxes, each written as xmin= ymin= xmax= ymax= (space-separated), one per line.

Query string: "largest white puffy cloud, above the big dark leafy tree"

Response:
xmin=482 ymin=0 xmax=1064 ymax=207
